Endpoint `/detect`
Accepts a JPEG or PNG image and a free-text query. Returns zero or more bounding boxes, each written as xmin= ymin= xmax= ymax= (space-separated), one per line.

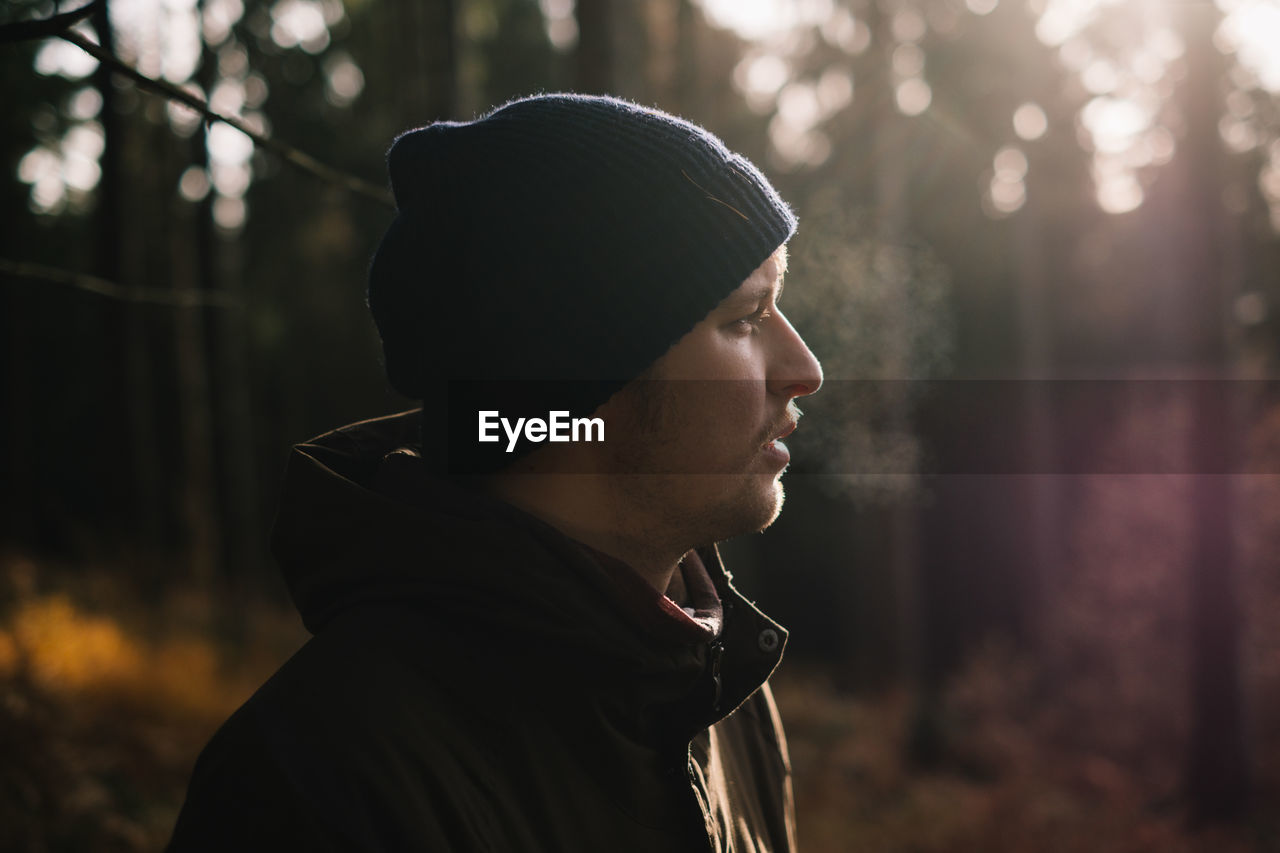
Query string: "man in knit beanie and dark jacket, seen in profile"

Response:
xmin=170 ymin=95 xmax=822 ymax=850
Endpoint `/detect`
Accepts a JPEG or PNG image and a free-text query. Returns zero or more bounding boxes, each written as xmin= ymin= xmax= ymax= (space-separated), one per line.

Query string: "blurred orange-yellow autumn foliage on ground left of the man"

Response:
xmin=0 ymin=557 xmax=302 ymax=853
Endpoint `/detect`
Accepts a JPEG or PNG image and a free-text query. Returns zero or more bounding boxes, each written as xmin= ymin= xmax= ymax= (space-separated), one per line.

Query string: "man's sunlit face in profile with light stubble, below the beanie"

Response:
xmin=598 ymin=250 xmax=822 ymax=543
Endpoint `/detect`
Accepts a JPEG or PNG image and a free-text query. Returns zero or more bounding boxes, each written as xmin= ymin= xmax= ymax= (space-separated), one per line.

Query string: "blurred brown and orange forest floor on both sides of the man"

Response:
xmin=0 ymin=558 xmax=1280 ymax=853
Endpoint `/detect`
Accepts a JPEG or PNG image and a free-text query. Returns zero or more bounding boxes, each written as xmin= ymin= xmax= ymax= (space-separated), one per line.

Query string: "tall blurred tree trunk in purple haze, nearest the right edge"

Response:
xmin=1171 ymin=4 xmax=1251 ymax=822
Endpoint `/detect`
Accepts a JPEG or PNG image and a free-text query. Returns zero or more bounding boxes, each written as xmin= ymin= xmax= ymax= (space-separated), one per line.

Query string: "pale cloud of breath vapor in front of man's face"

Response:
xmin=785 ymin=192 xmax=954 ymax=503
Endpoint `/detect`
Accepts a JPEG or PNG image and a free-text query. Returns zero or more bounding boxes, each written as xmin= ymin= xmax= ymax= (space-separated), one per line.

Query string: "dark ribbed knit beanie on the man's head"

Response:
xmin=369 ymin=95 xmax=796 ymax=473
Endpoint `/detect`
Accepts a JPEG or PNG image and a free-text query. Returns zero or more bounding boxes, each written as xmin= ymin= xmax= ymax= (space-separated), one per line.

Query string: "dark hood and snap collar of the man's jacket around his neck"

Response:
xmin=273 ymin=410 xmax=786 ymax=727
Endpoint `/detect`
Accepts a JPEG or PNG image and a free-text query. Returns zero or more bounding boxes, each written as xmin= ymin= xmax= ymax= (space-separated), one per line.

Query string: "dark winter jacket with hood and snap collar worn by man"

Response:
xmin=170 ymin=412 xmax=794 ymax=853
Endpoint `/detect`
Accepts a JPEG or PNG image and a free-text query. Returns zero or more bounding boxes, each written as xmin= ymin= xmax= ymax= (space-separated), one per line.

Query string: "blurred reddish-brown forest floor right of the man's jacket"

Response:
xmin=774 ymin=671 xmax=1280 ymax=853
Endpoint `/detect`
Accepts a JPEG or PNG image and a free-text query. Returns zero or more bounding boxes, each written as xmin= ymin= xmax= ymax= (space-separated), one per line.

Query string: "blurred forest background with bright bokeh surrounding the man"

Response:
xmin=0 ymin=0 xmax=1280 ymax=853
